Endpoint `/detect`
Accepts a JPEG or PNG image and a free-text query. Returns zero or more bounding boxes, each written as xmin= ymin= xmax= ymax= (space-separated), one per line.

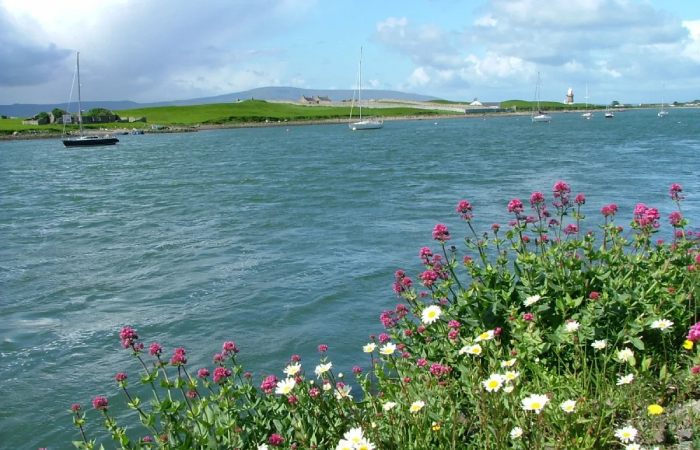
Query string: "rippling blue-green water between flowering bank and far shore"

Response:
xmin=0 ymin=109 xmax=700 ymax=449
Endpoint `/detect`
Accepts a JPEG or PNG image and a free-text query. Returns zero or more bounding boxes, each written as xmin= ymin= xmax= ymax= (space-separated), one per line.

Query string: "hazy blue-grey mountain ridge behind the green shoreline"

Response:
xmin=0 ymin=86 xmax=437 ymax=117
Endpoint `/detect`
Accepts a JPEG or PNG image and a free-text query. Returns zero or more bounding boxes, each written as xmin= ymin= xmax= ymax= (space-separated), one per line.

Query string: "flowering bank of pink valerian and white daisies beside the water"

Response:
xmin=67 ymin=182 xmax=700 ymax=450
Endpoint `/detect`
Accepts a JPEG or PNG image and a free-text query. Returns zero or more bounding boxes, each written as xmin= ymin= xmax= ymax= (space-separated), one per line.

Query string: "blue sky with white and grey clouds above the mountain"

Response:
xmin=0 ymin=0 xmax=700 ymax=104
